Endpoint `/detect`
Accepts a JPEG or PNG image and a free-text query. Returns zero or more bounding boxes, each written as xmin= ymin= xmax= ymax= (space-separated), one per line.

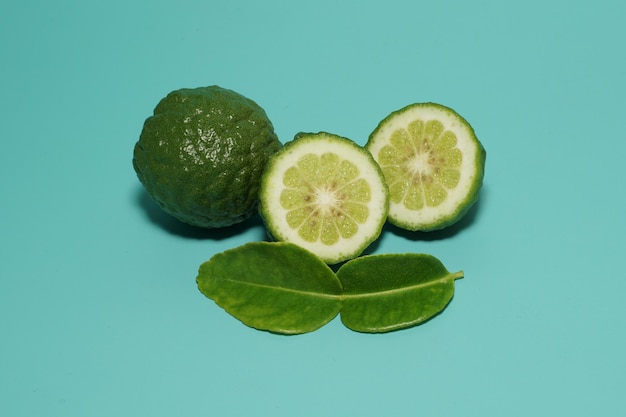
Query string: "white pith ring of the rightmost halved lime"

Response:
xmin=367 ymin=105 xmax=479 ymax=229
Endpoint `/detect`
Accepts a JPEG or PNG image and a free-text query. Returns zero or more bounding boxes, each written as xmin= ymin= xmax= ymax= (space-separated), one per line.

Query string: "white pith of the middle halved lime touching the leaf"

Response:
xmin=260 ymin=134 xmax=388 ymax=263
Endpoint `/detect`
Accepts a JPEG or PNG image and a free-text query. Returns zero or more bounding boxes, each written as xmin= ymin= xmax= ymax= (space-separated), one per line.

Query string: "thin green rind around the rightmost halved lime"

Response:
xmin=365 ymin=102 xmax=487 ymax=232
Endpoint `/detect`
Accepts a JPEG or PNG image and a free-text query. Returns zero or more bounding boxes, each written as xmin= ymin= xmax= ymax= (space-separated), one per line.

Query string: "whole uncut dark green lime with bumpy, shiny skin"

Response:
xmin=133 ymin=86 xmax=281 ymax=228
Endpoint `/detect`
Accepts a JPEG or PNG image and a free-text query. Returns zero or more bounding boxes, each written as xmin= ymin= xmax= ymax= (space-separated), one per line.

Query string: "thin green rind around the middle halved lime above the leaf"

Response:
xmin=259 ymin=132 xmax=389 ymax=265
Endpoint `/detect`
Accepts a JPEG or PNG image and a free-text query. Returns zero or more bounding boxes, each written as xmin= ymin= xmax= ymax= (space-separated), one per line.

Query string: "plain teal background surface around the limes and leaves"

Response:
xmin=0 ymin=0 xmax=626 ymax=417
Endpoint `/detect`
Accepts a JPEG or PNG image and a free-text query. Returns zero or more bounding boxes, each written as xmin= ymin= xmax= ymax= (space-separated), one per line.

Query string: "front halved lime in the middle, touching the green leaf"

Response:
xmin=259 ymin=132 xmax=389 ymax=264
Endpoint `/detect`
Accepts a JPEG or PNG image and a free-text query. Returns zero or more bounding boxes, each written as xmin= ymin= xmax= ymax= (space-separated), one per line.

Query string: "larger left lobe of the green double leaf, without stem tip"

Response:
xmin=196 ymin=242 xmax=342 ymax=334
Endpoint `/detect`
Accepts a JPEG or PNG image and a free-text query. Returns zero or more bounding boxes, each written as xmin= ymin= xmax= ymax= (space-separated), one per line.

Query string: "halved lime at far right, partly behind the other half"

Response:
xmin=365 ymin=103 xmax=486 ymax=231
